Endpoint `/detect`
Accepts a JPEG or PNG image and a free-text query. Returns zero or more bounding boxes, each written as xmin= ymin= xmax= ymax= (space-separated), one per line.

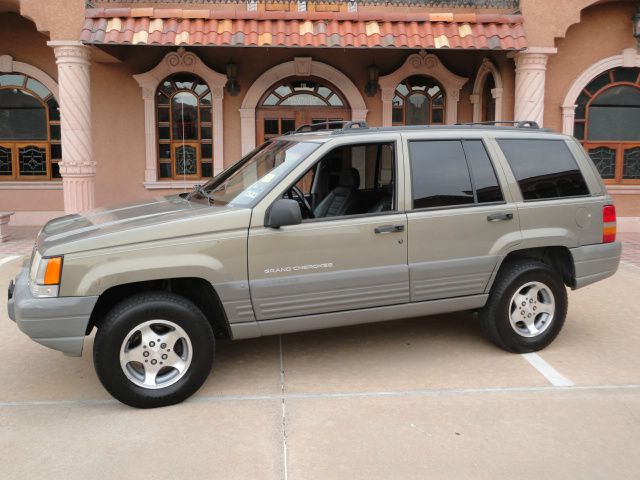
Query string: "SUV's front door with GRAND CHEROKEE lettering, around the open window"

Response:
xmin=248 ymin=134 xmax=409 ymax=322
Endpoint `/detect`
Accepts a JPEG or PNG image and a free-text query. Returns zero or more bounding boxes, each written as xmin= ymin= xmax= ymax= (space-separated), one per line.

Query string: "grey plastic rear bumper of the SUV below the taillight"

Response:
xmin=569 ymin=242 xmax=622 ymax=289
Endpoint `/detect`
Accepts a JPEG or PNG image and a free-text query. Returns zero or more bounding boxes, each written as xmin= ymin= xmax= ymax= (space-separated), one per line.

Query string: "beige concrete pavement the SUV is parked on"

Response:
xmin=0 ymin=256 xmax=640 ymax=480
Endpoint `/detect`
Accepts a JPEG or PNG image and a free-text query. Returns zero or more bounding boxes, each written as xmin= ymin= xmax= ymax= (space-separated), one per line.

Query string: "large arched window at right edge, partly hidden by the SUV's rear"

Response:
xmin=574 ymin=68 xmax=640 ymax=184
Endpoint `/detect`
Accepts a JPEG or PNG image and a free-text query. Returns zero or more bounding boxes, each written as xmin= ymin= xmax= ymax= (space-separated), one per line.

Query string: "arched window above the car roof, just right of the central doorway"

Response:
xmin=392 ymin=75 xmax=445 ymax=125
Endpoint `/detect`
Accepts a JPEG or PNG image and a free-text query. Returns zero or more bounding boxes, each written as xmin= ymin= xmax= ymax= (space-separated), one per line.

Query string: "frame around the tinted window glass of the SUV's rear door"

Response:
xmin=406 ymin=137 xmax=507 ymax=212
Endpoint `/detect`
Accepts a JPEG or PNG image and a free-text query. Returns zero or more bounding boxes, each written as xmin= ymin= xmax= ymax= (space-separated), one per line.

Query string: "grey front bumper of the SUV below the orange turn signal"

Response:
xmin=7 ymin=267 xmax=98 ymax=357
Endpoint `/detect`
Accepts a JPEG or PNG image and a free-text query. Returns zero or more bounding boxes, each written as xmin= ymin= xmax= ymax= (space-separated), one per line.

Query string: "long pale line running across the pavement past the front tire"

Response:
xmin=0 ymin=384 xmax=640 ymax=408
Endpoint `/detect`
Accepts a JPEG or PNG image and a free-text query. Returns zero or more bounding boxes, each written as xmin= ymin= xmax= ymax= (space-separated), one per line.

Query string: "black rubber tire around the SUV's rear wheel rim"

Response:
xmin=479 ymin=260 xmax=568 ymax=353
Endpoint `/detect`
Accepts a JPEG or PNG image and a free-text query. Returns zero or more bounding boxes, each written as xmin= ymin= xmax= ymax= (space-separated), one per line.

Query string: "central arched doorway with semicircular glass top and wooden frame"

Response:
xmin=256 ymin=78 xmax=351 ymax=144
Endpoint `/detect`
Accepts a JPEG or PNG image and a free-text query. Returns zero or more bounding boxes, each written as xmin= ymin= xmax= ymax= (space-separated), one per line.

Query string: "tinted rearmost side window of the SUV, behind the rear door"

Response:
xmin=498 ymin=139 xmax=589 ymax=200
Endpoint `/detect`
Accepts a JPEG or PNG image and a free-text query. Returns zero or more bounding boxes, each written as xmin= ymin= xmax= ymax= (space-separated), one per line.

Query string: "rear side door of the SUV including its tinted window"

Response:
xmin=405 ymin=136 xmax=521 ymax=302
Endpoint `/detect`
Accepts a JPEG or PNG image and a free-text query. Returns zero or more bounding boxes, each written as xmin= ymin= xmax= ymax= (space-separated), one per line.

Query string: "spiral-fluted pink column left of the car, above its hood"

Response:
xmin=47 ymin=40 xmax=96 ymax=213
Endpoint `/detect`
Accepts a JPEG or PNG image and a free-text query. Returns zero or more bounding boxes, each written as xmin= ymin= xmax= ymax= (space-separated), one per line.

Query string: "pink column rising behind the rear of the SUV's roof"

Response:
xmin=514 ymin=48 xmax=556 ymax=126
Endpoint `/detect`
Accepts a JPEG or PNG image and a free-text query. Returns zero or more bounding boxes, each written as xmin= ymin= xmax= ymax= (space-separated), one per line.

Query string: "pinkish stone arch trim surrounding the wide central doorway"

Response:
xmin=240 ymin=57 xmax=368 ymax=155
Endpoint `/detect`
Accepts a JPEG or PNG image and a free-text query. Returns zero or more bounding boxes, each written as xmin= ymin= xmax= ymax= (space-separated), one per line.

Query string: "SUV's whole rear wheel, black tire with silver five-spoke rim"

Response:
xmin=479 ymin=260 xmax=567 ymax=353
